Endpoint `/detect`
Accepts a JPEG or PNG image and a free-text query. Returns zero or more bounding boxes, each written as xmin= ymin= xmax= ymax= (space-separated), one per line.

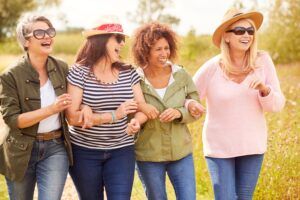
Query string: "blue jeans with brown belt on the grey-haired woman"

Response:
xmin=6 ymin=139 xmax=69 ymax=200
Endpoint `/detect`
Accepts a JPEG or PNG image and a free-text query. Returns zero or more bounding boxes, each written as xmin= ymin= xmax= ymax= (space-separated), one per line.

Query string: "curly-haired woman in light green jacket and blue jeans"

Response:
xmin=132 ymin=22 xmax=204 ymax=200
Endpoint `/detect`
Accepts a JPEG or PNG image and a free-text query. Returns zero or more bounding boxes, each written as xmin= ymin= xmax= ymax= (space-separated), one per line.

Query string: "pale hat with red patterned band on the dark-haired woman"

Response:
xmin=82 ymin=16 xmax=128 ymax=38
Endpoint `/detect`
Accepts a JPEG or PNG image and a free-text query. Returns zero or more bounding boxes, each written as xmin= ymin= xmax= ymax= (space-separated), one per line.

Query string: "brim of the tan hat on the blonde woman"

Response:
xmin=212 ymin=12 xmax=264 ymax=48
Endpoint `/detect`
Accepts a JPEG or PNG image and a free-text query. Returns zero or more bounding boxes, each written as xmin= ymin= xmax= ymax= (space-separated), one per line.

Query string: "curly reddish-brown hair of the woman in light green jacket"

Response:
xmin=132 ymin=22 xmax=177 ymax=67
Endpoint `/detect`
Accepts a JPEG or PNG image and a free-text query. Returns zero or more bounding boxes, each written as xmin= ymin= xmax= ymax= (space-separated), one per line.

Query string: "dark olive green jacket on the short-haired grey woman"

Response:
xmin=0 ymin=55 xmax=73 ymax=181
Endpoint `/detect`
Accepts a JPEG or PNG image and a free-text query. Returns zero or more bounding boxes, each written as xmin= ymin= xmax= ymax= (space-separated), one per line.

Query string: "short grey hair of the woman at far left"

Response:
xmin=16 ymin=15 xmax=53 ymax=51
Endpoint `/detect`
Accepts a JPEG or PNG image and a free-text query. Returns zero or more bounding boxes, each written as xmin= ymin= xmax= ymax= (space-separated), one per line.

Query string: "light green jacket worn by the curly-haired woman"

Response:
xmin=135 ymin=65 xmax=199 ymax=162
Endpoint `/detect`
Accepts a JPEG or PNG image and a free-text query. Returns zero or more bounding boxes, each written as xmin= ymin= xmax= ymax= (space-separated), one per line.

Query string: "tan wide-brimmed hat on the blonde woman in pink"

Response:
xmin=212 ymin=8 xmax=264 ymax=48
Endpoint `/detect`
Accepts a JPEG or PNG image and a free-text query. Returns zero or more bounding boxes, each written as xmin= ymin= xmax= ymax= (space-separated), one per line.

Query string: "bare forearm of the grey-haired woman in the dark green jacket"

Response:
xmin=17 ymin=106 xmax=55 ymax=128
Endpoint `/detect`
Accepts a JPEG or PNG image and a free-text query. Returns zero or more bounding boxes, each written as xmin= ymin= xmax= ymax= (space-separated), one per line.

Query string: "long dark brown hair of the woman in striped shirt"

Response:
xmin=75 ymin=34 xmax=131 ymax=70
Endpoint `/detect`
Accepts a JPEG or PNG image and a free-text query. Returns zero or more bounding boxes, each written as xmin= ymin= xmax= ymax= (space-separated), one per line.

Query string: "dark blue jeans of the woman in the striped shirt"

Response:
xmin=70 ymin=144 xmax=135 ymax=200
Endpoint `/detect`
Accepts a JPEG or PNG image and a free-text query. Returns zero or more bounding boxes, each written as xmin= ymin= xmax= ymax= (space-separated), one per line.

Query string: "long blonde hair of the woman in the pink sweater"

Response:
xmin=220 ymin=19 xmax=257 ymax=75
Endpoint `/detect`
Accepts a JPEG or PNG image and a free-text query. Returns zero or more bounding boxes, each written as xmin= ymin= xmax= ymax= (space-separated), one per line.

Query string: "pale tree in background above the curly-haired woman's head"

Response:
xmin=128 ymin=0 xmax=180 ymax=25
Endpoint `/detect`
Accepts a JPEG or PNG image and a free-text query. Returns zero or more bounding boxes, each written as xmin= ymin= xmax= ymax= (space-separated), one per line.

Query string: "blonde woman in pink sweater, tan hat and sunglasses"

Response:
xmin=188 ymin=9 xmax=285 ymax=200
